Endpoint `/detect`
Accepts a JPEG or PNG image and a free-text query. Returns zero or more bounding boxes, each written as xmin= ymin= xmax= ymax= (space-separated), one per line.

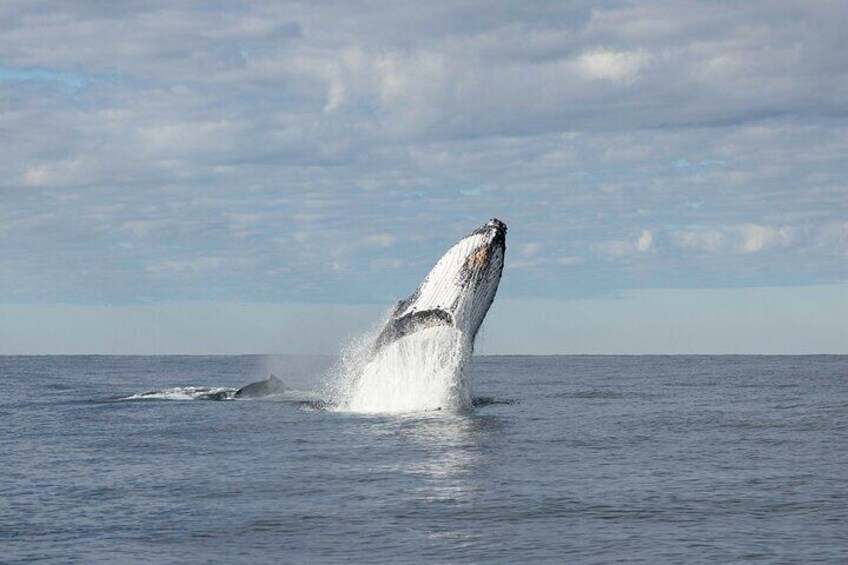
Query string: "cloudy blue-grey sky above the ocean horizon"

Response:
xmin=0 ymin=0 xmax=848 ymax=354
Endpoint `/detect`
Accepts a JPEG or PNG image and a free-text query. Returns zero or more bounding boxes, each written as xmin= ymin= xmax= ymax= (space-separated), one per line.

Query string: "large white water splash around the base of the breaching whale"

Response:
xmin=326 ymin=326 xmax=471 ymax=413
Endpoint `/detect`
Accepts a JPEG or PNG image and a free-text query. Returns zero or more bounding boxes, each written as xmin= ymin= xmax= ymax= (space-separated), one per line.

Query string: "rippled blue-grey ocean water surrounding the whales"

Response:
xmin=0 ymin=356 xmax=848 ymax=564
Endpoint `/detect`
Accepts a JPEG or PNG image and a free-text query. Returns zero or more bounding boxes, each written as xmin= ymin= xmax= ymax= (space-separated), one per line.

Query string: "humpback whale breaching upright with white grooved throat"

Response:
xmin=373 ymin=219 xmax=506 ymax=353
